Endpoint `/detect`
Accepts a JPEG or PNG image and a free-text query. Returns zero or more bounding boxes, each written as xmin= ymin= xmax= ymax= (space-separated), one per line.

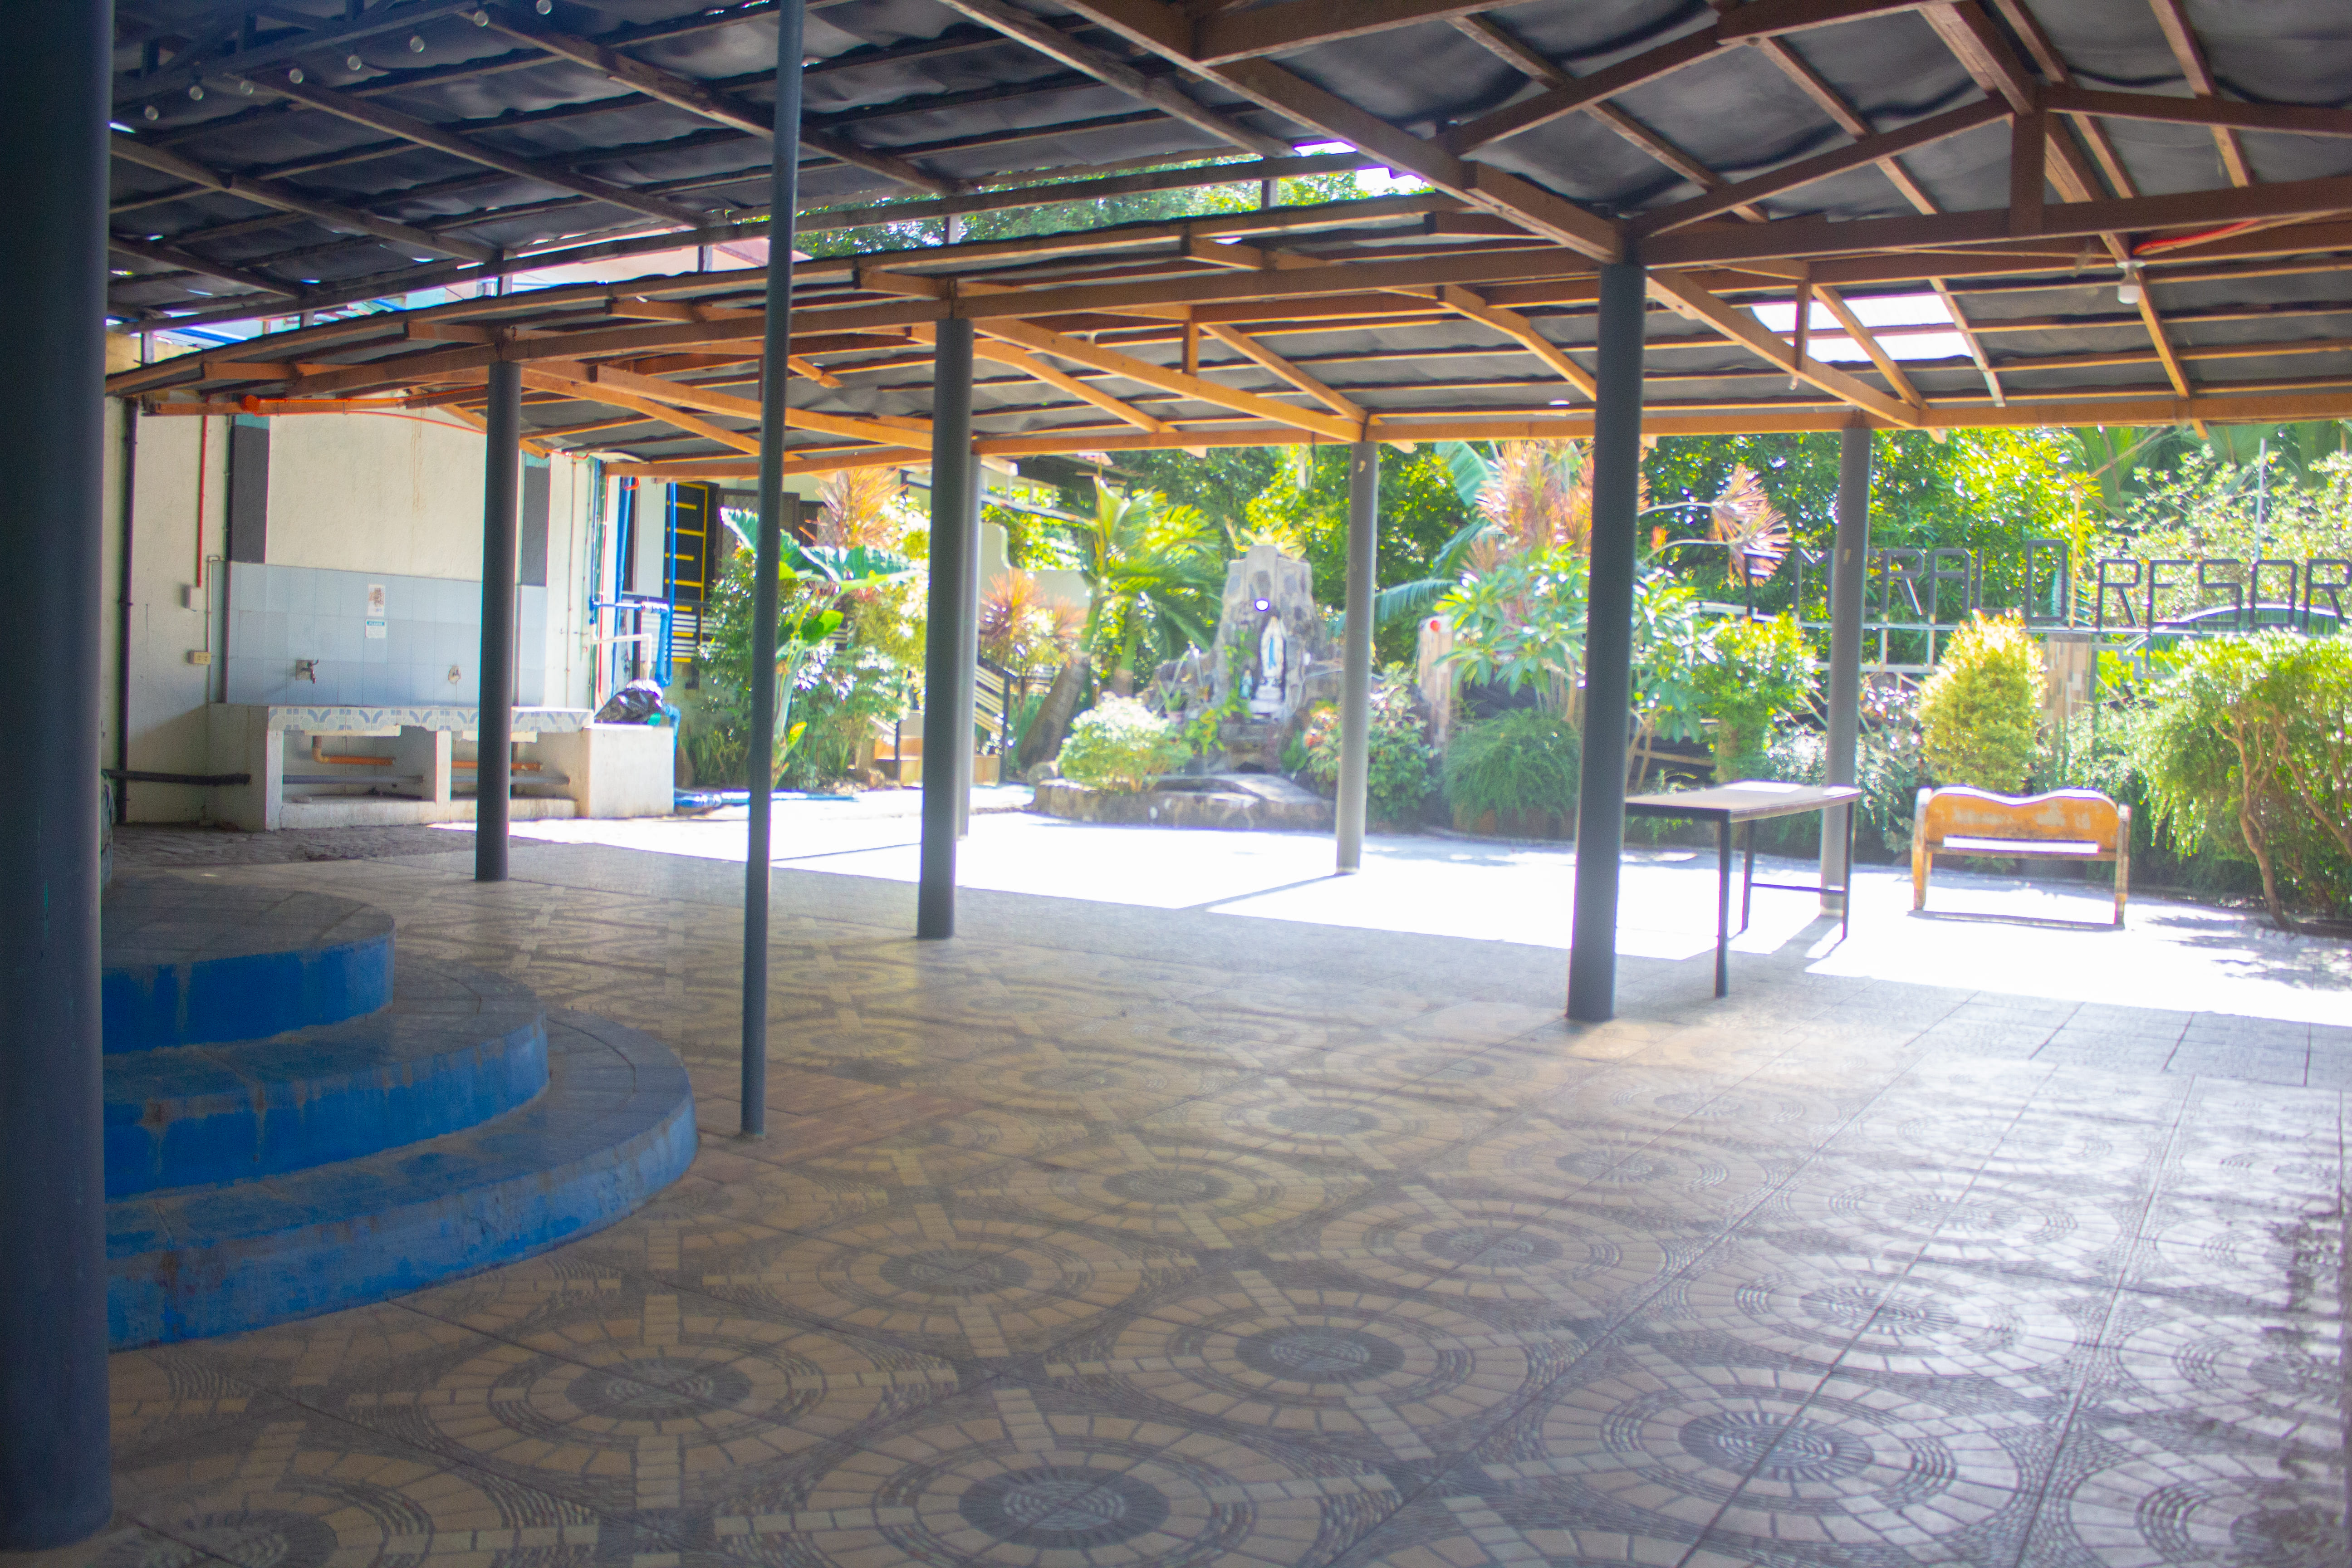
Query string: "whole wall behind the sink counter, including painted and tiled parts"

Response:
xmin=110 ymin=400 xmax=607 ymax=823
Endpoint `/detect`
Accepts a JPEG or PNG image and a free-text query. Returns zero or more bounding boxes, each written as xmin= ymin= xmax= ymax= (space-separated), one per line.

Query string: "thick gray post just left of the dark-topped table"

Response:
xmin=1569 ymin=261 xmax=1649 ymax=1023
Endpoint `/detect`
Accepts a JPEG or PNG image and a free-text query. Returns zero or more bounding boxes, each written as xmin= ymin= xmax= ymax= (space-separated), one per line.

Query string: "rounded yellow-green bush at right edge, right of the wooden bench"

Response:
xmin=2131 ymin=632 xmax=2352 ymax=929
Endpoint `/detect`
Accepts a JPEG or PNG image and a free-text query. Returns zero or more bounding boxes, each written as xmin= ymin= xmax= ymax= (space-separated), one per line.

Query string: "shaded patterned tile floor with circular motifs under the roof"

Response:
xmin=27 ymin=827 xmax=2352 ymax=1568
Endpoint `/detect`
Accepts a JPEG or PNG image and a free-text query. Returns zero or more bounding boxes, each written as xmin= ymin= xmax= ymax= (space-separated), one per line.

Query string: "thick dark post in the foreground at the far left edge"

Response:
xmin=0 ymin=5 xmax=110 ymax=1552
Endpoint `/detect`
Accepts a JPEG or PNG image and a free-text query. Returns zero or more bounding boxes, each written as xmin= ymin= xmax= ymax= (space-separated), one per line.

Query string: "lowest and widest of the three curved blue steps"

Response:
xmin=106 ymin=1013 xmax=694 ymax=1349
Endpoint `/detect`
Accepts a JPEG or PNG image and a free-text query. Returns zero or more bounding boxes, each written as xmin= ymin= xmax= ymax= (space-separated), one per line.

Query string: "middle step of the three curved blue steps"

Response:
xmin=106 ymin=959 xmax=548 ymax=1199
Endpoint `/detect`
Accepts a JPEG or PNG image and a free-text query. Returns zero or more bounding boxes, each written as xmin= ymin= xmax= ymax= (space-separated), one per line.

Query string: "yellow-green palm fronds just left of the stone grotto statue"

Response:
xmin=1054 ymin=480 xmax=1225 ymax=675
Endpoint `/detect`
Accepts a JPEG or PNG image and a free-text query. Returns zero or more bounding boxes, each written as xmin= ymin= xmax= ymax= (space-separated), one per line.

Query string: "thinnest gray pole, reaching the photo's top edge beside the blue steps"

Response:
xmin=736 ymin=0 xmax=807 ymax=1138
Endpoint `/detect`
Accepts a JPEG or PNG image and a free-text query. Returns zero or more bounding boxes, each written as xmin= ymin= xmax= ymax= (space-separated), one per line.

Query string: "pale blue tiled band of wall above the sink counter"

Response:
xmin=228 ymin=562 xmax=548 ymax=703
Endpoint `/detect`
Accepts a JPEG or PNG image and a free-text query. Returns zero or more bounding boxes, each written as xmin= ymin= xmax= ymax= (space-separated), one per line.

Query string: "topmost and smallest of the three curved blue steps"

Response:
xmin=101 ymin=877 xmax=393 ymax=1053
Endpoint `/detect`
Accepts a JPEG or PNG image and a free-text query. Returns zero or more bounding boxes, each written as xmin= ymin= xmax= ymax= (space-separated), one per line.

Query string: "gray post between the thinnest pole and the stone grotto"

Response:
xmin=915 ymin=320 xmax=979 ymax=941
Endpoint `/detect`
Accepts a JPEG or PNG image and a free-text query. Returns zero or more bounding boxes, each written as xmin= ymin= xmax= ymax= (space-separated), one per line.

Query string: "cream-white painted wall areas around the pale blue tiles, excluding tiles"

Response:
xmin=112 ymin=400 xmax=607 ymax=823
